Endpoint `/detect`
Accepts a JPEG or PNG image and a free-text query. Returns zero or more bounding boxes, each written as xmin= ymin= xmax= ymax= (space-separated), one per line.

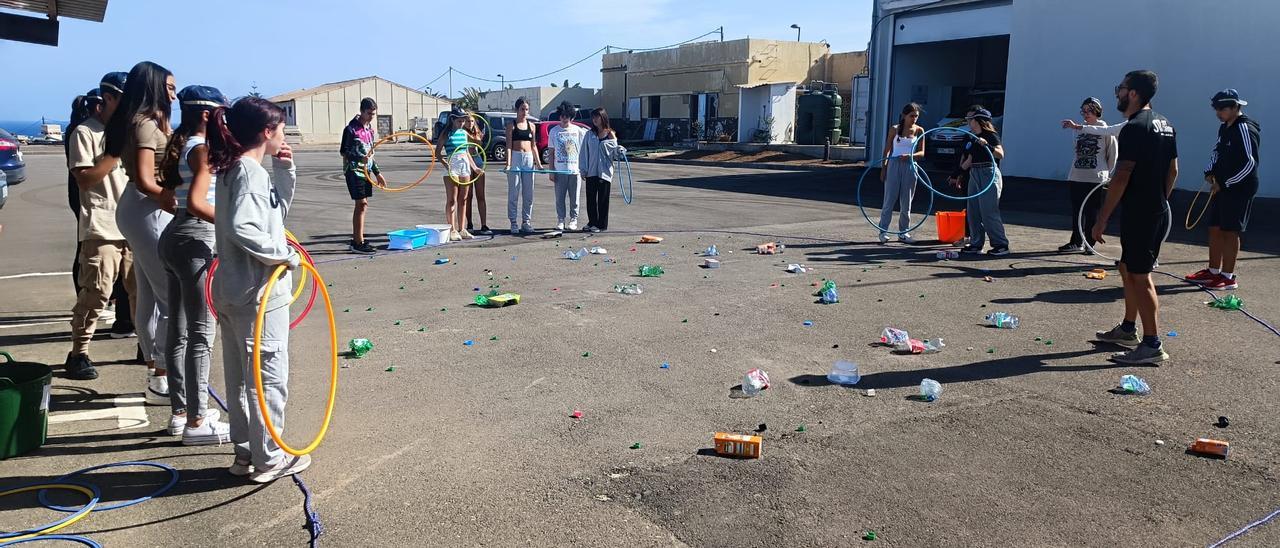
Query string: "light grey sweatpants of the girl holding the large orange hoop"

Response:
xmin=214 ymin=302 xmax=289 ymax=470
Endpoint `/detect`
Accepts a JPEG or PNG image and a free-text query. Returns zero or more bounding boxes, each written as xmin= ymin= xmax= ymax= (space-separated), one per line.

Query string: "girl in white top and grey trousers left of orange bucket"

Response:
xmin=879 ymin=102 xmax=924 ymax=243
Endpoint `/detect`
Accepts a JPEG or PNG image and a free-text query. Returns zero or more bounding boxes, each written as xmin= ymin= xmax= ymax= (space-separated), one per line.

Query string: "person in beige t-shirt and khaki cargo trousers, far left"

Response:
xmin=65 ymin=73 xmax=133 ymax=380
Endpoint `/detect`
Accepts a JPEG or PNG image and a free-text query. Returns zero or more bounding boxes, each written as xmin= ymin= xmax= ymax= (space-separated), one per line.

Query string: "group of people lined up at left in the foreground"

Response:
xmin=65 ymin=61 xmax=311 ymax=483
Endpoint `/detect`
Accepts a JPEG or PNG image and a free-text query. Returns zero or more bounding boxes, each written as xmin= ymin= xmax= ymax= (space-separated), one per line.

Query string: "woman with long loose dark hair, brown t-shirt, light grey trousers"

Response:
xmin=106 ymin=61 xmax=183 ymax=407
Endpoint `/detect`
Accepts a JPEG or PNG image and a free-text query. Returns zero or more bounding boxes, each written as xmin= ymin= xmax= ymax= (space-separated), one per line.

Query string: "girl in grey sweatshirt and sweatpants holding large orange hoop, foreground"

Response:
xmin=207 ymin=97 xmax=311 ymax=483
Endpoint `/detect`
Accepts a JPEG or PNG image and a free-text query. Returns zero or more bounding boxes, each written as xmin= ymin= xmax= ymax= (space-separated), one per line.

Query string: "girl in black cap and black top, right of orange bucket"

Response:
xmin=951 ymin=108 xmax=1009 ymax=256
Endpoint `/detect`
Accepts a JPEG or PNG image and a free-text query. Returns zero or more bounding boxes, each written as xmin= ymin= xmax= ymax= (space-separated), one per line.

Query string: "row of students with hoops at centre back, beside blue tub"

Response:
xmin=339 ymin=97 xmax=626 ymax=254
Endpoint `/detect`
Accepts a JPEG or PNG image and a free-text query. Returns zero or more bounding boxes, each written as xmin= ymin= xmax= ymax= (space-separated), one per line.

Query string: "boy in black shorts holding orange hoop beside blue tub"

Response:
xmin=338 ymin=97 xmax=387 ymax=254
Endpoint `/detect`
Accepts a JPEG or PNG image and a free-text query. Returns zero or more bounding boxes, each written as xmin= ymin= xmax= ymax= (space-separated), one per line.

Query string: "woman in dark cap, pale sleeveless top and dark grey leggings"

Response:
xmin=160 ymin=86 xmax=230 ymax=446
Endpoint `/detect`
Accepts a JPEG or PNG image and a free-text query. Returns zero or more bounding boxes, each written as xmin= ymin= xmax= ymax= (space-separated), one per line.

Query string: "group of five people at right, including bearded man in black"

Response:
xmin=879 ymin=70 xmax=1261 ymax=364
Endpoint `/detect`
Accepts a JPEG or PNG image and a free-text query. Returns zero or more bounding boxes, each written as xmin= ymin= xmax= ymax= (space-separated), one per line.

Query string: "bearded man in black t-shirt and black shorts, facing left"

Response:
xmin=1093 ymin=70 xmax=1178 ymax=364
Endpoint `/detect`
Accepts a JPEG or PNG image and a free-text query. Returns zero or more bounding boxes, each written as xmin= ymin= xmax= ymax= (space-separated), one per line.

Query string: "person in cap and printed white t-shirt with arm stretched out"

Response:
xmin=1057 ymin=97 xmax=1120 ymax=254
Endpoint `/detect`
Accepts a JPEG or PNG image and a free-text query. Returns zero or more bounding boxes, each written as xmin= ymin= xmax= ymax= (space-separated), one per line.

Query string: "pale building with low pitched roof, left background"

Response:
xmin=270 ymin=76 xmax=452 ymax=143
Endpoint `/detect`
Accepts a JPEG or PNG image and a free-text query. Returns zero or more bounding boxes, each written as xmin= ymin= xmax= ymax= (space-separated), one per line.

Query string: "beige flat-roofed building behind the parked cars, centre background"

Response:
xmin=600 ymin=38 xmax=865 ymax=141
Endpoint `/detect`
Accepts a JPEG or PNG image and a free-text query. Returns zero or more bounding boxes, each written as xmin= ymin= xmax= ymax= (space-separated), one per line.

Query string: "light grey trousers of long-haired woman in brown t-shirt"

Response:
xmin=115 ymin=185 xmax=174 ymax=373
